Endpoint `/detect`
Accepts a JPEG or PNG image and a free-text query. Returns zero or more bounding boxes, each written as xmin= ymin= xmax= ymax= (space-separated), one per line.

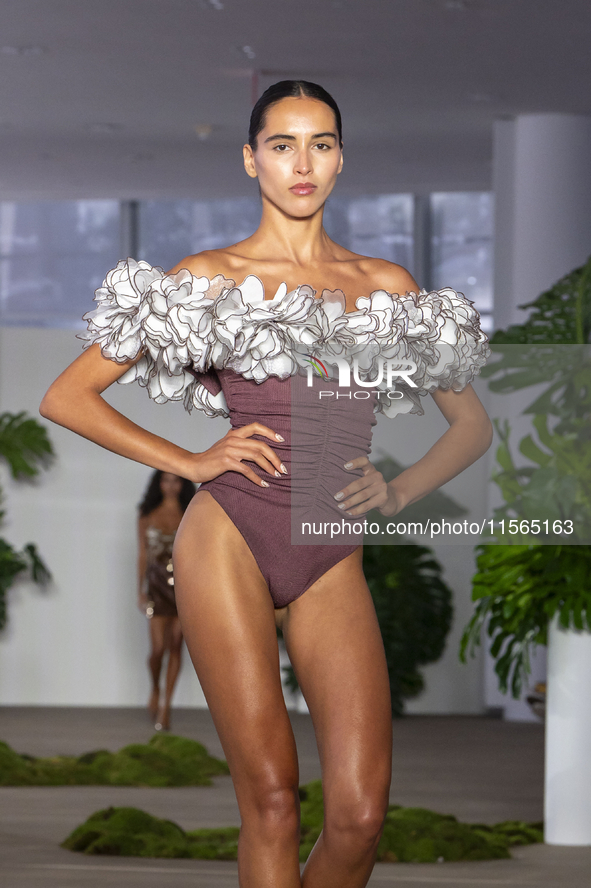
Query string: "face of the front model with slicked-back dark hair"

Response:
xmin=244 ymin=97 xmax=343 ymax=218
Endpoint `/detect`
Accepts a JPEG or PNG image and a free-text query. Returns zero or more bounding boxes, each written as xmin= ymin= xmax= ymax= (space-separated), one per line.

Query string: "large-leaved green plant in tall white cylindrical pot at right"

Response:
xmin=460 ymin=258 xmax=591 ymax=844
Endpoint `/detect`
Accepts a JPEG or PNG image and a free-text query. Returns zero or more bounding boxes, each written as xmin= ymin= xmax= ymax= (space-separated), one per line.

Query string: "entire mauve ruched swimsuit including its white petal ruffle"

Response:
xmin=80 ymin=259 xmax=489 ymax=608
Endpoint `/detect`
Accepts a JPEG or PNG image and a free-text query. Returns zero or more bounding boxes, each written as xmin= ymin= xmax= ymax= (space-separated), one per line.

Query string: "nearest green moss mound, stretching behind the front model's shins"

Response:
xmin=63 ymin=780 xmax=542 ymax=863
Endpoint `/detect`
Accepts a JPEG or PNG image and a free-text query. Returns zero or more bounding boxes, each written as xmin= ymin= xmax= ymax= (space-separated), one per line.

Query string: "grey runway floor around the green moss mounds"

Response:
xmin=0 ymin=707 xmax=591 ymax=888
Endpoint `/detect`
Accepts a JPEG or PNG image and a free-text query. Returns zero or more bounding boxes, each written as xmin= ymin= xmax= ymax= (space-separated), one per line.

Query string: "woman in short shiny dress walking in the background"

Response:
xmin=138 ymin=469 xmax=196 ymax=731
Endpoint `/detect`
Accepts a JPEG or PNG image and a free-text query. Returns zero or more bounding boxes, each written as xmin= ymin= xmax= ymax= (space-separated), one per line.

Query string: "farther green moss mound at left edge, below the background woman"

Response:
xmin=0 ymin=734 xmax=229 ymax=786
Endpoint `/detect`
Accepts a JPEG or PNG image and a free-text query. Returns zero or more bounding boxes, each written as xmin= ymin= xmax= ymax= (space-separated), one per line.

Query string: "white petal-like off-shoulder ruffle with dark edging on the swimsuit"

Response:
xmin=80 ymin=259 xmax=489 ymax=416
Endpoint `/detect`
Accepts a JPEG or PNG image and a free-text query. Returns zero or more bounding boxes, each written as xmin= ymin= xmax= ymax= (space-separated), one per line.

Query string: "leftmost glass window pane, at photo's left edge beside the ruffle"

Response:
xmin=0 ymin=200 xmax=120 ymax=327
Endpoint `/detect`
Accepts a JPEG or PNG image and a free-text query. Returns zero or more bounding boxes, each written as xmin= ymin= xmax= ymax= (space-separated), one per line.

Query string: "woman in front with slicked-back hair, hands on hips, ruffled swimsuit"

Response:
xmin=41 ymin=81 xmax=491 ymax=888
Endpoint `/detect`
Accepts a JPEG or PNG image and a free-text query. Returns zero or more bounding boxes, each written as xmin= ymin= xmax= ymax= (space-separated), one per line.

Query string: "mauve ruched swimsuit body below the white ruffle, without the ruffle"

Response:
xmin=196 ymin=370 xmax=376 ymax=608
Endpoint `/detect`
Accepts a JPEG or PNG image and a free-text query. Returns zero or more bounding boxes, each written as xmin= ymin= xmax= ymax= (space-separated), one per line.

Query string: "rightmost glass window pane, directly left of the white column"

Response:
xmin=431 ymin=191 xmax=494 ymax=332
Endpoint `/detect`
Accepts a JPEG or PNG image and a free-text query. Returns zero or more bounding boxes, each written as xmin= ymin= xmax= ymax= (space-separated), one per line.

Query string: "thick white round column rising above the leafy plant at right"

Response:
xmin=493 ymin=114 xmax=591 ymax=328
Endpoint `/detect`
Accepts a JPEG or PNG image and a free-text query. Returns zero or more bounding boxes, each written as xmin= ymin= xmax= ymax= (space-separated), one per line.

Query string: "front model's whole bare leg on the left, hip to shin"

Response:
xmin=174 ymin=491 xmax=301 ymax=888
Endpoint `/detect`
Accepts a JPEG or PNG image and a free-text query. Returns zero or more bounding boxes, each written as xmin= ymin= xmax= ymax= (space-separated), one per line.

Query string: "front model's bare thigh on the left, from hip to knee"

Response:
xmin=174 ymin=491 xmax=297 ymax=802
